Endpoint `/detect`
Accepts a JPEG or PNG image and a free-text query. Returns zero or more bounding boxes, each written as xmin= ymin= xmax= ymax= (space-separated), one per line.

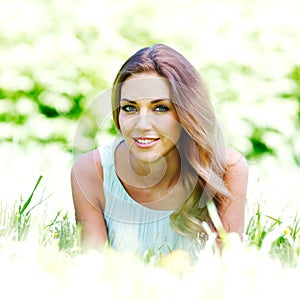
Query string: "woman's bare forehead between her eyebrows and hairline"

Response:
xmin=121 ymin=73 xmax=170 ymax=100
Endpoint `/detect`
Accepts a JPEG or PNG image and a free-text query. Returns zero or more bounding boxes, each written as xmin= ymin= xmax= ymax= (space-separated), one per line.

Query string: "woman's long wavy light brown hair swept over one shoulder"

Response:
xmin=112 ymin=44 xmax=231 ymax=237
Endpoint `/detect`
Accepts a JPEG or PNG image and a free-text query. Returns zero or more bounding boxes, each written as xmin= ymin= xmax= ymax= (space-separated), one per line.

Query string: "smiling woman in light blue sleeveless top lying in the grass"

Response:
xmin=71 ymin=44 xmax=248 ymax=254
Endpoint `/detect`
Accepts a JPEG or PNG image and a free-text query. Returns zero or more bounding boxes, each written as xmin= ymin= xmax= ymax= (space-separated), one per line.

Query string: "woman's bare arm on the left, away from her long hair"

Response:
xmin=71 ymin=150 xmax=107 ymax=249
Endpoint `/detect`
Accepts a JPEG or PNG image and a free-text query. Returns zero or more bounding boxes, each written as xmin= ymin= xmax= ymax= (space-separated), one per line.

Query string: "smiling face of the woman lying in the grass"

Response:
xmin=119 ymin=73 xmax=181 ymax=162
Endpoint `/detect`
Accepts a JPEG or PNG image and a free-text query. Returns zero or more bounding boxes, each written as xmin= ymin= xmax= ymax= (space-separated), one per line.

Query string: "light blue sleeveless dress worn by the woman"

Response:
xmin=98 ymin=140 xmax=199 ymax=255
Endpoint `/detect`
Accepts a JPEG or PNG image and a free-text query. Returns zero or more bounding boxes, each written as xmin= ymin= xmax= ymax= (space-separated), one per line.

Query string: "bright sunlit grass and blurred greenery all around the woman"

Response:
xmin=0 ymin=0 xmax=300 ymax=299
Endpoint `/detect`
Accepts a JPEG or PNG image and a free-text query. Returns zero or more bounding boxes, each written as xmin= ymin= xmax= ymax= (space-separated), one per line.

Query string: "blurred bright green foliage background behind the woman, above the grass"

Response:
xmin=0 ymin=0 xmax=300 ymax=216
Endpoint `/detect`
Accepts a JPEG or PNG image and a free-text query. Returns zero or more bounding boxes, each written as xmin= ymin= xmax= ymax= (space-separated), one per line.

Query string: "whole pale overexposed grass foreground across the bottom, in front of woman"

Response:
xmin=0 ymin=177 xmax=300 ymax=300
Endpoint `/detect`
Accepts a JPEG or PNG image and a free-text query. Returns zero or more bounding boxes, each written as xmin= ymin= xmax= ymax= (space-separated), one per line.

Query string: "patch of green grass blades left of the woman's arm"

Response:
xmin=0 ymin=176 xmax=80 ymax=253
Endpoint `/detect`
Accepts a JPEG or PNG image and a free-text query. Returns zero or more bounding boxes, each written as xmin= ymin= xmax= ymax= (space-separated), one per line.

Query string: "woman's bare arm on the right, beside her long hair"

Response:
xmin=220 ymin=150 xmax=248 ymax=238
